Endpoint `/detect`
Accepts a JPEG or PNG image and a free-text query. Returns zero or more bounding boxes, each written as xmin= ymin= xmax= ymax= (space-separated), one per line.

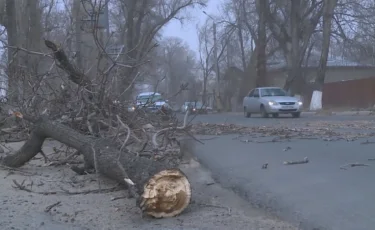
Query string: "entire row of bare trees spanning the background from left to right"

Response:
xmin=0 ymin=0 xmax=375 ymax=111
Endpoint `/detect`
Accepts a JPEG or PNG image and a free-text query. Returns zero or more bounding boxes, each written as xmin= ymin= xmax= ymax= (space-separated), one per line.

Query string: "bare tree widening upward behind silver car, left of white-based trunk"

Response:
xmin=265 ymin=0 xmax=323 ymax=94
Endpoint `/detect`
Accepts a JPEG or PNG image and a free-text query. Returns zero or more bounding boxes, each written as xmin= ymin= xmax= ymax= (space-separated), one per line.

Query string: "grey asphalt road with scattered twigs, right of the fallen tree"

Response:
xmin=188 ymin=114 xmax=375 ymax=230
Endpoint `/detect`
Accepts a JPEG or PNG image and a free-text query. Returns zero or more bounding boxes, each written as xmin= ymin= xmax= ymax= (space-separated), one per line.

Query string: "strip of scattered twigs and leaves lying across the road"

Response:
xmin=190 ymin=120 xmax=375 ymax=144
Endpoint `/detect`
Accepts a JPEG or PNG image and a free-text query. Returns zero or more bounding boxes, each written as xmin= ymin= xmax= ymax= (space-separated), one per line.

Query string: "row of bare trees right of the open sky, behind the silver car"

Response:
xmin=195 ymin=0 xmax=375 ymax=109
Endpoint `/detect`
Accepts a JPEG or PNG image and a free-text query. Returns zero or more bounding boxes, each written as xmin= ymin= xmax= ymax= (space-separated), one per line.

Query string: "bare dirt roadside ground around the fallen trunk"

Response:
xmin=0 ymin=141 xmax=298 ymax=230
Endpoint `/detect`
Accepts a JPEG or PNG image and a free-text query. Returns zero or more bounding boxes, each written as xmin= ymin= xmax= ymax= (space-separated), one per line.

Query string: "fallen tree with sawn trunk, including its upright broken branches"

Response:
xmin=1 ymin=40 xmax=191 ymax=218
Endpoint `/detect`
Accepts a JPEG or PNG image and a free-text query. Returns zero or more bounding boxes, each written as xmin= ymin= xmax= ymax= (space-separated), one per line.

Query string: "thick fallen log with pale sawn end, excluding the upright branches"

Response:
xmin=1 ymin=115 xmax=191 ymax=218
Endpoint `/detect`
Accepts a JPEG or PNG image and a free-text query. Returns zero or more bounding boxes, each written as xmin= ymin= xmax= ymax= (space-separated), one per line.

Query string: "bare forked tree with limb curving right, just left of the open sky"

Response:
xmin=116 ymin=0 xmax=207 ymax=99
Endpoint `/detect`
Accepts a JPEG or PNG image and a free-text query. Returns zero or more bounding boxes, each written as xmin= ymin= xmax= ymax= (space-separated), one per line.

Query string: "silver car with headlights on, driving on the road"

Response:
xmin=243 ymin=87 xmax=303 ymax=118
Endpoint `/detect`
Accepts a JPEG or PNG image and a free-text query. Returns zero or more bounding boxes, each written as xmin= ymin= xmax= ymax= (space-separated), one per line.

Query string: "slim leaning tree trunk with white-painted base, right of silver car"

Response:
xmin=310 ymin=0 xmax=337 ymax=110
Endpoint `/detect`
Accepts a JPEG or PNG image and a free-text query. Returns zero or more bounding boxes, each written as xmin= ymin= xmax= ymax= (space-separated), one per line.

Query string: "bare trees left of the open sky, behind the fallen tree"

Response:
xmin=0 ymin=0 xmax=207 ymax=111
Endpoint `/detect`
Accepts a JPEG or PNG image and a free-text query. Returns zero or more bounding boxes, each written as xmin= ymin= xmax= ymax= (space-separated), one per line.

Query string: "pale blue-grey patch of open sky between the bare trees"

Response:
xmin=163 ymin=0 xmax=222 ymax=52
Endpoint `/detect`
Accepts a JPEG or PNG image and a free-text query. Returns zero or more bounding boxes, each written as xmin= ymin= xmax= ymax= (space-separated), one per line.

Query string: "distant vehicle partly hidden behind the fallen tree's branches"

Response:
xmin=128 ymin=92 xmax=172 ymax=113
